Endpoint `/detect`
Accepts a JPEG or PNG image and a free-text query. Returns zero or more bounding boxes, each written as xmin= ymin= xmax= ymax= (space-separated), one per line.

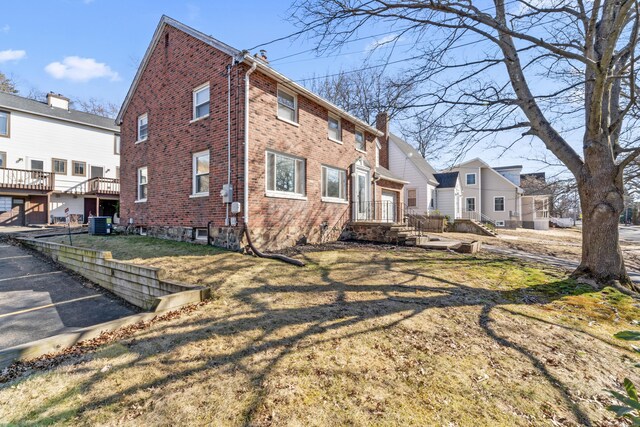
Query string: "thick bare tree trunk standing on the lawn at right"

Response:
xmin=573 ymin=144 xmax=638 ymax=291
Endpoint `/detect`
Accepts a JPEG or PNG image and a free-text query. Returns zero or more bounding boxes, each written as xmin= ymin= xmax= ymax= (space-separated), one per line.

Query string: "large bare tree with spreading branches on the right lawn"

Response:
xmin=291 ymin=0 xmax=640 ymax=289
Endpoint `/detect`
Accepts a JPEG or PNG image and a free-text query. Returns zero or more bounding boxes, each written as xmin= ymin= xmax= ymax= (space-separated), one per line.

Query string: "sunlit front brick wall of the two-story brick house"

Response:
xmin=249 ymin=72 xmax=375 ymax=248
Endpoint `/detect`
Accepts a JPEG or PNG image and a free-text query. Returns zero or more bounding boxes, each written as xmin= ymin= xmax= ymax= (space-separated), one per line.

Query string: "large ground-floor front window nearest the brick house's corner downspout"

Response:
xmin=266 ymin=151 xmax=306 ymax=197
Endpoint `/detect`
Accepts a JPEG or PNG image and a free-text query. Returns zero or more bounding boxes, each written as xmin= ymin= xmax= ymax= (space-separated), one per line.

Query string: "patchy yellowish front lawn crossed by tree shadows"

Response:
xmin=5 ymin=236 xmax=640 ymax=426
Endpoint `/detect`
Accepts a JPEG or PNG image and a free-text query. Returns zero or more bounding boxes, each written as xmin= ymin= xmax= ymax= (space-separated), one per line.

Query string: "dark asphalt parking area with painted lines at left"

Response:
xmin=0 ymin=241 xmax=136 ymax=350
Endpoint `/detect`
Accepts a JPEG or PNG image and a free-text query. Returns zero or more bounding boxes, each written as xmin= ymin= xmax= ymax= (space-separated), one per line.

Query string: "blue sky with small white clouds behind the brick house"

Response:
xmin=0 ymin=0 xmax=560 ymax=171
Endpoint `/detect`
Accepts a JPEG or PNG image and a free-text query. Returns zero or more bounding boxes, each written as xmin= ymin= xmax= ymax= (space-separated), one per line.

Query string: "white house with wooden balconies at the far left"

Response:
xmin=0 ymin=92 xmax=120 ymax=225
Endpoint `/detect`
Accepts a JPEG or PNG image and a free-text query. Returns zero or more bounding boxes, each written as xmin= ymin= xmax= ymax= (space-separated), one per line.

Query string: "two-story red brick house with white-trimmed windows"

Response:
xmin=117 ymin=16 xmax=404 ymax=249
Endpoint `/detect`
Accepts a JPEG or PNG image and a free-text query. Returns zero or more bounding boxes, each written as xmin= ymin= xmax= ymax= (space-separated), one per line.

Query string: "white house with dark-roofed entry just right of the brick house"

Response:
xmin=389 ymin=134 xmax=462 ymax=219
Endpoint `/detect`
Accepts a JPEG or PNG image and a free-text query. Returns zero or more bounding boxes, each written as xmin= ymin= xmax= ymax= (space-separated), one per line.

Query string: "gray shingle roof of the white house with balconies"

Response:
xmin=0 ymin=92 xmax=120 ymax=132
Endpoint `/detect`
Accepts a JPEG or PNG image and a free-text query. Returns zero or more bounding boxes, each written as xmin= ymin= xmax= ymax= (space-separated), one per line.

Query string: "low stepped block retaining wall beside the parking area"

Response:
xmin=19 ymin=239 xmax=210 ymax=311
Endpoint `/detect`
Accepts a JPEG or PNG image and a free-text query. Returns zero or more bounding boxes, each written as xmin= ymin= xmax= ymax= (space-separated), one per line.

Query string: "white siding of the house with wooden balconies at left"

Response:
xmin=0 ymin=111 xmax=120 ymax=192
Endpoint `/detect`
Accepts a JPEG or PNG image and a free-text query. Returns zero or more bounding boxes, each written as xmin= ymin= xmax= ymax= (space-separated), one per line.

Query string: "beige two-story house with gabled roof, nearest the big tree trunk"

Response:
xmin=449 ymin=159 xmax=524 ymax=228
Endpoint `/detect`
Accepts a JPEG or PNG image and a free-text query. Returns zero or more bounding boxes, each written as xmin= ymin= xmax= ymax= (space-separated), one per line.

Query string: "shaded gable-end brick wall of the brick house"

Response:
xmin=120 ymin=26 xmax=242 ymax=231
